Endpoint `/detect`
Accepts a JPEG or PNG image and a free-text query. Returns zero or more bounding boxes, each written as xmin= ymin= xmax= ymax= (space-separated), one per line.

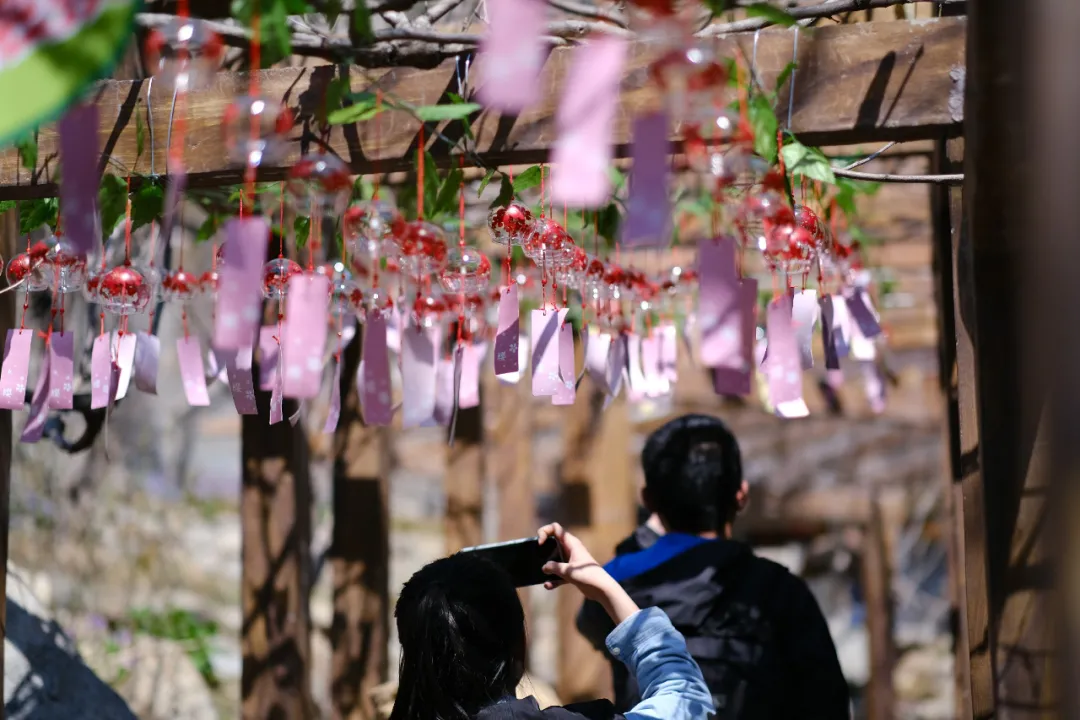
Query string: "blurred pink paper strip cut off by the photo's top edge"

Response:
xmin=476 ymin=0 xmax=546 ymax=114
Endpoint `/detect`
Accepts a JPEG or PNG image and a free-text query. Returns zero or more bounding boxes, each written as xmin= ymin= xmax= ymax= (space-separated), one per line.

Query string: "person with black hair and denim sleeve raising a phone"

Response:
xmin=390 ymin=524 xmax=714 ymax=720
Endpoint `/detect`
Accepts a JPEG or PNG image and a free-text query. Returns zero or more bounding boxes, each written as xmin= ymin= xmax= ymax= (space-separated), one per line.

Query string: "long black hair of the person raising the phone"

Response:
xmin=390 ymin=553 xmax=525 ymax=720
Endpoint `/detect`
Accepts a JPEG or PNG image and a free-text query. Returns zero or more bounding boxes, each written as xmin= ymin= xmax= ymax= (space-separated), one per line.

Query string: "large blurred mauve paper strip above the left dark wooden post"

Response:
xmin=212 ymin=217 xmax=270 ymax=351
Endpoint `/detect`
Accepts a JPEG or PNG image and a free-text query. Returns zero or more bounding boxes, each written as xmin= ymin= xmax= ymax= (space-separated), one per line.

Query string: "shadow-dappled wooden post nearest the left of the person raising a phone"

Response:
xmin=329 ymin=328 xmax=391 ymax=720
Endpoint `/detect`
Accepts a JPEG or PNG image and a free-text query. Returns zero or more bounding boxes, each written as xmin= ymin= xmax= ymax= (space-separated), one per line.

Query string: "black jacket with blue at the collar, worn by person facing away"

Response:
xmin=578 ymin=534 xmax=850 ymax=720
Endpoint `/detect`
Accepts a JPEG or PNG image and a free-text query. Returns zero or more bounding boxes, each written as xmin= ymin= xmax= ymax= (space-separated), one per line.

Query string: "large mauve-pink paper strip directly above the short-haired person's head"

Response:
xmin=698 ymin=237 xmax=750 ymax=372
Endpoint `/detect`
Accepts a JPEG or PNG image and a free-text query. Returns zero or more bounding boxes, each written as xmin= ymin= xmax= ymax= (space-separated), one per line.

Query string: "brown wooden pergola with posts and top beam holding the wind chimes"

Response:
xmin=0 ymin=0 xmax=1080 ymax=718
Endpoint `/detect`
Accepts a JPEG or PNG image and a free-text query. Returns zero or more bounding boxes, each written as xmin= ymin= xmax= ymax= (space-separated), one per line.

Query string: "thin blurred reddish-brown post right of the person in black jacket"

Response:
xmin=862 ymin=495 xmax=896 ymax=720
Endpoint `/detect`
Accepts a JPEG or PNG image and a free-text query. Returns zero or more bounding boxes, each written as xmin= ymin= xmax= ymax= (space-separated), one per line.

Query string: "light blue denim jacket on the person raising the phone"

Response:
xmin=475 ymin=608 xmax=715 ymax=720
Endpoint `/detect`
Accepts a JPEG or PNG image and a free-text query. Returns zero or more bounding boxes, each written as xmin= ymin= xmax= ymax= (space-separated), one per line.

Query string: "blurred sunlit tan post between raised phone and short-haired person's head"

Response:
xmin=556 ymin=378 xmax=637 ymax=703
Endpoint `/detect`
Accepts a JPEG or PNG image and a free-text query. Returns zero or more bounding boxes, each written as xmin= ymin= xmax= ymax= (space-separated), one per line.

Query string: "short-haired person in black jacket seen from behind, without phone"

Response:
xmin=578 ymin=415 xmax=851 ymax=720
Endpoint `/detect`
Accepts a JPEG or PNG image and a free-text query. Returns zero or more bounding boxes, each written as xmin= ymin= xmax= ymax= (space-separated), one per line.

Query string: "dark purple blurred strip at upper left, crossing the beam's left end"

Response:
xmin=57 ymin=103 xmax=100 ymax=255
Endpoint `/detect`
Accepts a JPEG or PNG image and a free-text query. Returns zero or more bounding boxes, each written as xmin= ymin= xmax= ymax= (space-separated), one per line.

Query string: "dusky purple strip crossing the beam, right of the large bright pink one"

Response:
xmin=621 ymin=112 xmax=672 ymax=247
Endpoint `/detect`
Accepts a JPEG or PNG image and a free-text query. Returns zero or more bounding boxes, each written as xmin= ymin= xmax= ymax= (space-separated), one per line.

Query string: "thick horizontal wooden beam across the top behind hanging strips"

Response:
xmin=0 ymin=17 xmax=967 ymax=199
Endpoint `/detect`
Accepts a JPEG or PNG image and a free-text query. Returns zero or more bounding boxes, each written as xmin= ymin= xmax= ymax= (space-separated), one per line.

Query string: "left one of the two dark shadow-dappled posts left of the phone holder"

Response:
xmin=240 ymin=390 xmax=314 ymax=720
